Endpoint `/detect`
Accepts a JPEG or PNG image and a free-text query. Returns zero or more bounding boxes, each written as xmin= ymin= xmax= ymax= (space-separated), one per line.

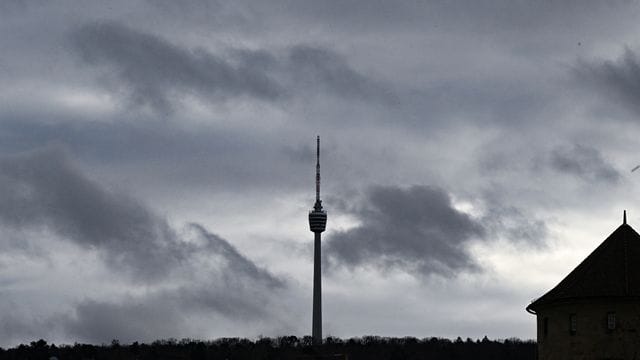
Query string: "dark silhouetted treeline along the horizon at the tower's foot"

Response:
xmin=0 ymin=336 xmax=536 ymax=360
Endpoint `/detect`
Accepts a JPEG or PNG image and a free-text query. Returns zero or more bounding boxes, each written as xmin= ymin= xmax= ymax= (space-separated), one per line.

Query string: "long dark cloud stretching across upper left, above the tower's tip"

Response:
xmin=71 ymin=22 xmax=393 ymax=112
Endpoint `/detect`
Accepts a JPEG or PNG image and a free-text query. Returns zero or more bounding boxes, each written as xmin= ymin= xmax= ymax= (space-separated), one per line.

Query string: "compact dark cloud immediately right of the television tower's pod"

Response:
xmin=326 ymin=186 xmax=485 ymax=276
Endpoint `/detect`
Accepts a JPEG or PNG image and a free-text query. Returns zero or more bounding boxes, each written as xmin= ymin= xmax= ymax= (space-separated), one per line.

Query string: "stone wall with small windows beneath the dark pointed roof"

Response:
xmin=537 ymin=298 xmax=640 ymax=360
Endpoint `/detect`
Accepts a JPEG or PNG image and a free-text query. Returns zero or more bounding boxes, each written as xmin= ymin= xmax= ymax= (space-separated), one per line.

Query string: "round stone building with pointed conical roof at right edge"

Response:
xmin=526 ymin=213 xmax=640 ymax=360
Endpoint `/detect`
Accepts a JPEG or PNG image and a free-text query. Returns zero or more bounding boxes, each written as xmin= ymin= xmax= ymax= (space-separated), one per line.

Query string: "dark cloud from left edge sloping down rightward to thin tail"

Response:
xmin=0 ymin=148 xmax=281 ymax=286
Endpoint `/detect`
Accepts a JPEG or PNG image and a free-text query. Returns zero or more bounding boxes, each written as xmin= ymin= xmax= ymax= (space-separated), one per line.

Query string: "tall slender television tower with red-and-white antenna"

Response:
xmin=309 ymin=136 xmax=327 ymax=345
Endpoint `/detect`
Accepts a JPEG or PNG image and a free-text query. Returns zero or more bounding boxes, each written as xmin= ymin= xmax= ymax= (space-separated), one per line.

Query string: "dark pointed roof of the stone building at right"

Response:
xmin=527 ymin=222 xmax=640 ymax=313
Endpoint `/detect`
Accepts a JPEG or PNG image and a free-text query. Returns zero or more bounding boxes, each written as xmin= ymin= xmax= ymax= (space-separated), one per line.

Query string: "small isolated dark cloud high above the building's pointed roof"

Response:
xmin=549 ymin=144 xmax=620 ymax=184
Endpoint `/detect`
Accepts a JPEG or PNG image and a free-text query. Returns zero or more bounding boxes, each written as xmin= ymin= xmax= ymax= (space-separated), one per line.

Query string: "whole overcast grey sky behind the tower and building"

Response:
xmin=0 ymin=0 xmax=640 ymax=347
